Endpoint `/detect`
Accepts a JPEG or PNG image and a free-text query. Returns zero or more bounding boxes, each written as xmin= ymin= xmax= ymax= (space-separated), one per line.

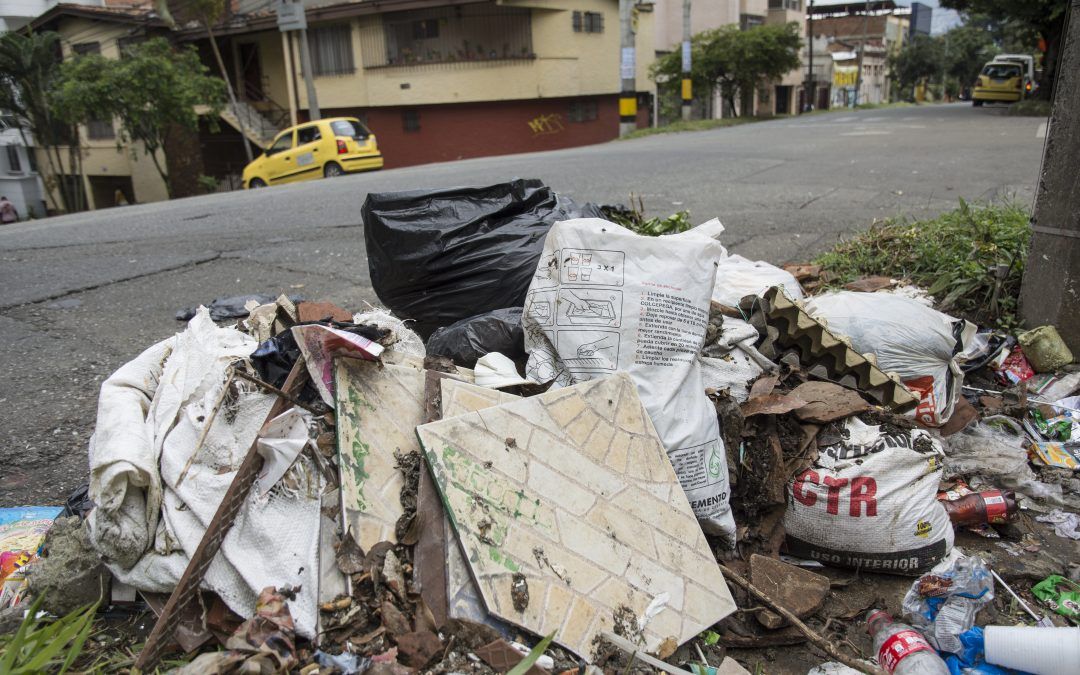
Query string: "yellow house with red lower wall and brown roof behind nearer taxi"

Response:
xmin=27 ymin=0 xmax=654 ymax=206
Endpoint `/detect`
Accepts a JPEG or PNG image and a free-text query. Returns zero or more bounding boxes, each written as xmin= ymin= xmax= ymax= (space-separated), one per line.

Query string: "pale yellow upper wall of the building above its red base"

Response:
xmin=291 ymin=0 xmax=654 ymax=109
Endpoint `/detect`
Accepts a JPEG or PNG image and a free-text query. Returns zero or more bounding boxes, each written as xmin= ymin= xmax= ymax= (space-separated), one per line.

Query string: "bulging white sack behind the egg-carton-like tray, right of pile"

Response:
xmin=806 ymin=291 xmax=975 ymax=427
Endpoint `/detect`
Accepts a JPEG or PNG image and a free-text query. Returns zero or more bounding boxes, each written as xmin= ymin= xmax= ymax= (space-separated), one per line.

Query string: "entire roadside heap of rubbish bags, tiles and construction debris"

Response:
xmin=0 ymin=180 xmax=1080 ymax=674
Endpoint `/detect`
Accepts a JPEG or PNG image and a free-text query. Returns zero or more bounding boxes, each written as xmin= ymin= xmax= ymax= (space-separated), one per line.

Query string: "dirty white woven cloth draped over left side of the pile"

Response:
xmin=87 ymin=308 xmax=322 ymax=636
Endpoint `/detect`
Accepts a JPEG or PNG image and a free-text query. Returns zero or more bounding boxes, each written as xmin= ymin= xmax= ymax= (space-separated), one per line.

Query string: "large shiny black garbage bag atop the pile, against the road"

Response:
xmin=362 ymin=178 xmax=600 ymax=340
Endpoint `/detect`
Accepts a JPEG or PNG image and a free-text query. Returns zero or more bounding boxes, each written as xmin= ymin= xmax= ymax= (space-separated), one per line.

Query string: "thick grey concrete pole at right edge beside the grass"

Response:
xmin=1020 ymin=0 xmax=1080 ymax=355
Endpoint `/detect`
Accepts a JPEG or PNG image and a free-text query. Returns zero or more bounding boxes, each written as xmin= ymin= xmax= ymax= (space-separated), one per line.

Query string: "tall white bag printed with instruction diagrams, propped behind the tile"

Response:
xmin=522 ymin=218 xmax=734 ymax=542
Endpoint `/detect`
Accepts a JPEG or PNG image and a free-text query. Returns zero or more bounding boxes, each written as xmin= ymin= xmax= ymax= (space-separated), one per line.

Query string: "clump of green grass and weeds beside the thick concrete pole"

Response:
xmin=815 ymin=200 xmax=1031 ymax=328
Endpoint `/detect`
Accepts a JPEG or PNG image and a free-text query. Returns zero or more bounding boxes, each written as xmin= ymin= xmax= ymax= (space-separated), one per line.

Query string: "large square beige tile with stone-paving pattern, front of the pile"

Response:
xmin=417 ymin=373 xmax=734 ymax=658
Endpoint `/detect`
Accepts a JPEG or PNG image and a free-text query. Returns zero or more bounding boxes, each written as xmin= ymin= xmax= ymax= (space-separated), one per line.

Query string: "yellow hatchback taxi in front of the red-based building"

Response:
xmin=243 ymin=118 xmax=382 ymax=189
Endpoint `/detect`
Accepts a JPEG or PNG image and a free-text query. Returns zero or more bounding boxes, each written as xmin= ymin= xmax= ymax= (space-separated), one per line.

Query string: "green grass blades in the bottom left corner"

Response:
xmin=0 ymin=597 xmax=97 ymax=675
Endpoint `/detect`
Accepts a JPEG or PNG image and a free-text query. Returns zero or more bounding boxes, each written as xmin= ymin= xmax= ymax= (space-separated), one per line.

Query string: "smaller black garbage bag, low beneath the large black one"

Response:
xmin=427 ymin=307 xmax=525 ymax=368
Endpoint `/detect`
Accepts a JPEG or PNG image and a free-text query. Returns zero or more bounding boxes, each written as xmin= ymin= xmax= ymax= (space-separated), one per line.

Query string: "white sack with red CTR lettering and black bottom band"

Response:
xmin=784 ymin=417 xmax=953 ymax=575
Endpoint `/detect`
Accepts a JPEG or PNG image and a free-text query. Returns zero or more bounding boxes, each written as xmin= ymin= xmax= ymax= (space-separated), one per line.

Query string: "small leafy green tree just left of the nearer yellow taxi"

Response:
xmin=57 ymin=38 xmax=225 ymax=197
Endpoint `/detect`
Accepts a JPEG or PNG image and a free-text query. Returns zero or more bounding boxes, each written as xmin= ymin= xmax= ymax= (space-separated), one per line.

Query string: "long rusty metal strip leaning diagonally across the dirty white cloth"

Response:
xmin=135 ymin=359 xmax=308 ymax=671
